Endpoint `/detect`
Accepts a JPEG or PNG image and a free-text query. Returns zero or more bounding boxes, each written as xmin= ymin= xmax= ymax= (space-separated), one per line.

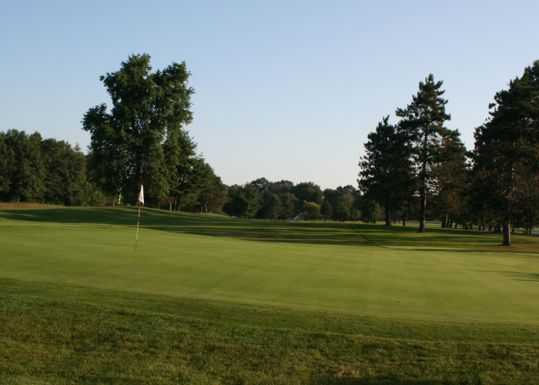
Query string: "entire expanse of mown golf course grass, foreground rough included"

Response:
xmin=0 ymin=208 xmax=539 ymax=385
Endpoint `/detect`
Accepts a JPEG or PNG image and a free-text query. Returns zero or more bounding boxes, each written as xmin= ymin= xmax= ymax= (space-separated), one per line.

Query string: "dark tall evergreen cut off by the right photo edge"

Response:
xmin=474 ymin=61 xmax=539 ymax=246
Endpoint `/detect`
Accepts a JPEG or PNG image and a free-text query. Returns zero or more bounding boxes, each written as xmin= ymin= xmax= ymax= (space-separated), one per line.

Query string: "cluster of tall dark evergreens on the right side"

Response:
xmin=358 ymin=61 xmax=539 ymax=245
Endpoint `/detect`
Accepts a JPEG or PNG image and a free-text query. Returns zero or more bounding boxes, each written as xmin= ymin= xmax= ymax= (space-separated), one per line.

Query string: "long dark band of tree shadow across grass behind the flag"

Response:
xmin=0 ymin=208 xmax=539 ymax=254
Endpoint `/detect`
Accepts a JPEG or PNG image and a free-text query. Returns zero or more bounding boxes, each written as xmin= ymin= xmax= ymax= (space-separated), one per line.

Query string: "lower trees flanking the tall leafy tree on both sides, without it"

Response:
xmin=0 ymin=130 xmax=226 ymax=212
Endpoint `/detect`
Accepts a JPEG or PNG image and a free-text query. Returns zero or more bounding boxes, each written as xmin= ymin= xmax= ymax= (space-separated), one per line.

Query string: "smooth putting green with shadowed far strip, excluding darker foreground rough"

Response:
xmin=0 ymin=208 xmax=539 ymax=324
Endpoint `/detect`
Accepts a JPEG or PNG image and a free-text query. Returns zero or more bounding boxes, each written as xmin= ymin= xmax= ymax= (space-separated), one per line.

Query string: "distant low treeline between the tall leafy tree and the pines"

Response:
xmin=223 ymin=178 xmax=377 ymax=221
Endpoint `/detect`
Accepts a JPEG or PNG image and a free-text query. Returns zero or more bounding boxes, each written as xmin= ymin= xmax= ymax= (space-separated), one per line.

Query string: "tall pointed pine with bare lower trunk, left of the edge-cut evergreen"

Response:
xmin=397 ymin=74 xmax=450 ymax=232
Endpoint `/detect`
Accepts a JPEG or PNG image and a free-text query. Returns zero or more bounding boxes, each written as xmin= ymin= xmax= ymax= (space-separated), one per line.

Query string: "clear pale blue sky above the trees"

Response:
xmin=0 ymin=0 xmax=539 ymax=187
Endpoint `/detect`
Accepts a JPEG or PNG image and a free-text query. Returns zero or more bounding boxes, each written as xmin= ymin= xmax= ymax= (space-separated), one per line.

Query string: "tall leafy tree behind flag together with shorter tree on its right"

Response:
xmin=79 ymin=54 xmax=226 ymax=212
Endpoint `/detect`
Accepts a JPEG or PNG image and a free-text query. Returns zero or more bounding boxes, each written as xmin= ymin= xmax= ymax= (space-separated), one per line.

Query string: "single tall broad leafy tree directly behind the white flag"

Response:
xmin=83 ymin=55 xmax=193 ymax=203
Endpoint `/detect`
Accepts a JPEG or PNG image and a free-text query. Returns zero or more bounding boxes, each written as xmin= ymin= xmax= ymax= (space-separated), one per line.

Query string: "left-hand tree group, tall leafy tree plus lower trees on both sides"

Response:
xmin=0 ymin=55 xmax=226 ymax=212
